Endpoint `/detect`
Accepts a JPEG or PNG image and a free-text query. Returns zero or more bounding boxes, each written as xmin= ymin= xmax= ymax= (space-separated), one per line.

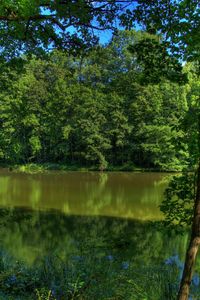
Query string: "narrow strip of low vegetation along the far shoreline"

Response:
xmin=0 ymin=163 xmax=181 ymax=174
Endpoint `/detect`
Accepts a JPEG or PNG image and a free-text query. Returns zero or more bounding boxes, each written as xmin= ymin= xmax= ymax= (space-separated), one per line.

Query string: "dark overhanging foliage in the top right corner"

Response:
xmin=125 ymin=0 xmax=200 ymax=64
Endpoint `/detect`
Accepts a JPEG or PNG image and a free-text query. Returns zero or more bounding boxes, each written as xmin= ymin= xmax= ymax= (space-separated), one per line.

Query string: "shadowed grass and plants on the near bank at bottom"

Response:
xmin=0 ymin=253 xmax=181 ymax=300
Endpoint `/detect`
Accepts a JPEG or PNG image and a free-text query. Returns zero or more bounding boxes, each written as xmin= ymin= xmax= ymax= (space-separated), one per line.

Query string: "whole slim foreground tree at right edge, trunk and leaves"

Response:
xmin=161 ymin=64 xmax=200 ymax=299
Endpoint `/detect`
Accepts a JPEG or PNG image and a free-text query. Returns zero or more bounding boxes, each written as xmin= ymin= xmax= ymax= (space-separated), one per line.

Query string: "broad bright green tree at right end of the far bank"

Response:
xmin=129 ymin=81 xmax=188 ymax=170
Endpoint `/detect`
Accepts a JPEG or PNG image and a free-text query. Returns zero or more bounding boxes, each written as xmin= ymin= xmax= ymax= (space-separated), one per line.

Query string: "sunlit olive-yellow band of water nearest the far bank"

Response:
xmin=0 ymin=170 xmax=169 ymax=220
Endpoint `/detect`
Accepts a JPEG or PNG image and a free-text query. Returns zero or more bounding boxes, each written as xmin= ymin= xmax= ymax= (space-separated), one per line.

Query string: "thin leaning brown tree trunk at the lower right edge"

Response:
xmin=177 ymin=115 xmax=200 ymax=300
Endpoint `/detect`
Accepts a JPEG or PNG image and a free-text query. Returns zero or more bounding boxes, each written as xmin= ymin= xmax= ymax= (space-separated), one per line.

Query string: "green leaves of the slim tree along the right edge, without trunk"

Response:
xmin=161 ymin=63 xmax=200 ymax=232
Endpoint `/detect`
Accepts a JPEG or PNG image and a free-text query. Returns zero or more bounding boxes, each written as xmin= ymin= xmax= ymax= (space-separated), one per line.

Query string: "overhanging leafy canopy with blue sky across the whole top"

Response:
xmin=0 ymin=0 xmax=200 ymax=60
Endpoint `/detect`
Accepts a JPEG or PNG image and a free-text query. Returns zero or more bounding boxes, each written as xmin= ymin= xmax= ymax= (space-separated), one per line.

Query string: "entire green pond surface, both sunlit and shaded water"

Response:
xmin=0 ymin=170 xmax=187 ymax=266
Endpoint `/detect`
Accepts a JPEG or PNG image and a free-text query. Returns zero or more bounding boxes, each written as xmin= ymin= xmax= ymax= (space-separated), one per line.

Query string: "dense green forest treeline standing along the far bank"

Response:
xmin=0 ymin=31 xmax=196 ymax=170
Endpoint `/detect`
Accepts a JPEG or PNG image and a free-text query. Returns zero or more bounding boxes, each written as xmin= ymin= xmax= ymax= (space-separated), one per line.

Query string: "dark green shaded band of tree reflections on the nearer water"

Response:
xmin=0 ymin=209 xmax=188 ymax=265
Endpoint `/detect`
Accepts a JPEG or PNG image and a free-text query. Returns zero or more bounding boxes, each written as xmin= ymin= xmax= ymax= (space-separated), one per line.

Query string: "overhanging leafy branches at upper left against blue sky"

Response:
xmin=0 ymin=0 xmax=136 ymax=59
